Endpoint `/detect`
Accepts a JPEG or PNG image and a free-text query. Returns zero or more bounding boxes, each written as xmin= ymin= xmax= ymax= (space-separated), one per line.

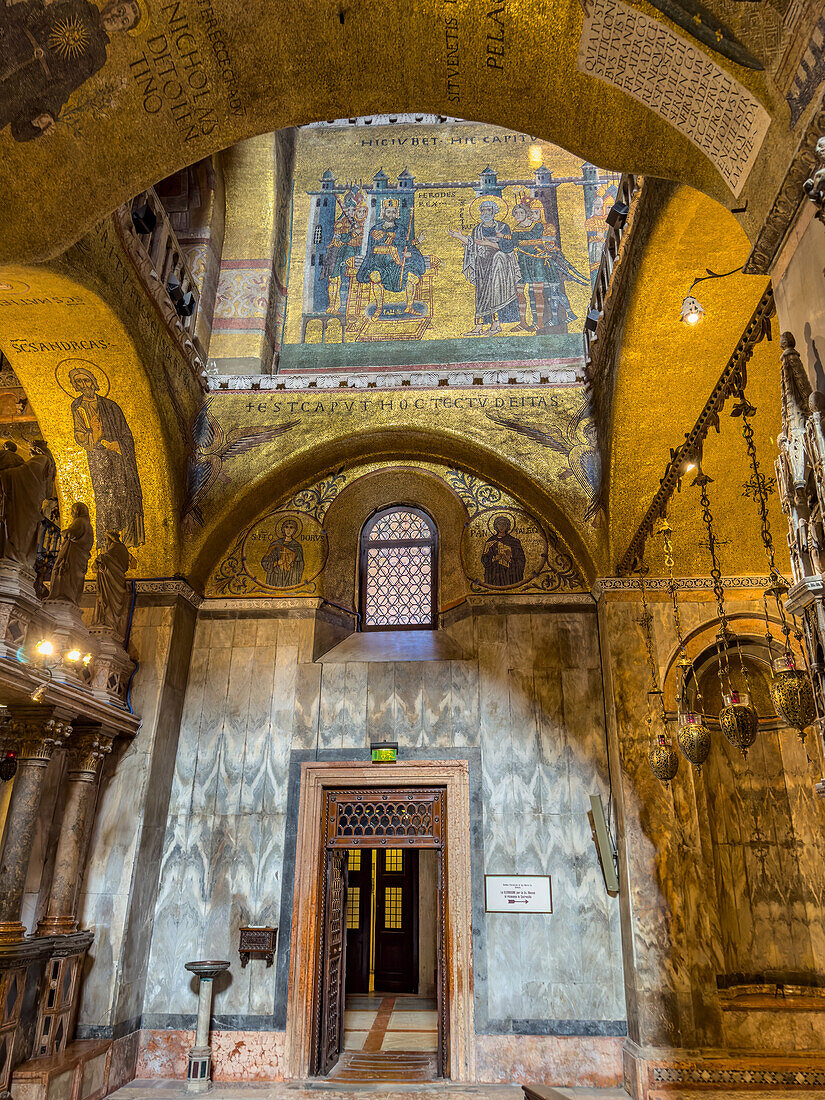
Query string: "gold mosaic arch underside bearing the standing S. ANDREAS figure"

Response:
xmin=0 ymin=267 xmax=179 ymax=576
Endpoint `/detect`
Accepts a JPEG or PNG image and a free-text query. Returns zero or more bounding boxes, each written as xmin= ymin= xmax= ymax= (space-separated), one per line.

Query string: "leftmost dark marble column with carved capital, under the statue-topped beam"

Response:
xmin=0 ymin=706 xmax=72 ymax=944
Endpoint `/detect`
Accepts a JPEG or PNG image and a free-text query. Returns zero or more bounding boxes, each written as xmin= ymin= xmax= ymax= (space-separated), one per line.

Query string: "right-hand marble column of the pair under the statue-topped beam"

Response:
xmin=37 ymin=723 xmax=112 ymax=936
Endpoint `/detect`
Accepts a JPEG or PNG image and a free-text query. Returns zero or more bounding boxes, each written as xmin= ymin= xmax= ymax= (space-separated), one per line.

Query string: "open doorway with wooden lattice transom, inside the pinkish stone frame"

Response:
xmin=316 ymin=790 xmax=448 ymax=1081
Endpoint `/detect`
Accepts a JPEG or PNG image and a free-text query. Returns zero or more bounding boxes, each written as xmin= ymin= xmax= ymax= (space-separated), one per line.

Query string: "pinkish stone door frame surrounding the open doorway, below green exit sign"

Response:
xmin=285 ymin=760 xmax=475 ymax=1081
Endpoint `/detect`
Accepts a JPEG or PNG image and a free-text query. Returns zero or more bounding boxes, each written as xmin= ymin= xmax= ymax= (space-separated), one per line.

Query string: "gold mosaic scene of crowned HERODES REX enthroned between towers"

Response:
xmin=282 ymin=123 xmax=617 ymax=369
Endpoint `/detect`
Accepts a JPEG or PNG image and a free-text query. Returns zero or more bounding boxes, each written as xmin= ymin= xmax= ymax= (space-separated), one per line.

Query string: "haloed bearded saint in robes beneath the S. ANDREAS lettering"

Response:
xmin=55 ymin=359 xmax=146 ymax=547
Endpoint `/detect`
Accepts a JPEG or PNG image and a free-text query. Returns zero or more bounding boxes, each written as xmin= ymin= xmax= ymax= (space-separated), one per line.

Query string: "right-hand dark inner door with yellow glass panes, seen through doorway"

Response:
xmin=374 ymin=848 xmax=418 ymax=993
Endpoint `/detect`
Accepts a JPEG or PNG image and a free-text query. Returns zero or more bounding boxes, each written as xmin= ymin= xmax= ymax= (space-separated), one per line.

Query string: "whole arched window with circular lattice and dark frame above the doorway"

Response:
xmin=360 ymin=505 xmax=438 ymax=630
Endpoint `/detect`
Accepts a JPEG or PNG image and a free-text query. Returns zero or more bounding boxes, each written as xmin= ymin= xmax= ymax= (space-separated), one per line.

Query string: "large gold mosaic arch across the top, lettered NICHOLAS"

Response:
xmin=0 ymin=0 xmax=809 ymax=261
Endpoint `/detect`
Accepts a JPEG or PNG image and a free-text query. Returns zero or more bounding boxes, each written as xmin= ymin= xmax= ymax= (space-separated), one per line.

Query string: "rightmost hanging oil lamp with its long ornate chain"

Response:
xmin=730 ymin=389 xmax=817 ymax=741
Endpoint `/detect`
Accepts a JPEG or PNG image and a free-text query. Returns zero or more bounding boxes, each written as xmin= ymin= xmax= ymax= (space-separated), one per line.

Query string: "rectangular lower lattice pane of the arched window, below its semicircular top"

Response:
xmin=364 ymin=547 xmax=432 ymax=626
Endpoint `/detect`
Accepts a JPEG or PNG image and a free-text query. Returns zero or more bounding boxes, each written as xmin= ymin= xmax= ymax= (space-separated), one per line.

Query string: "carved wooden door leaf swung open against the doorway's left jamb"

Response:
xmin=318 ymin=851 xmax=347 ymax=1074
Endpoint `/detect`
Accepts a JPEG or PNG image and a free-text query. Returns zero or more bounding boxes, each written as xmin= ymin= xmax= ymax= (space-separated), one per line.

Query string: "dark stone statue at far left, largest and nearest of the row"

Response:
xmin=0 ymin=440 xmax=55 ymax=569
